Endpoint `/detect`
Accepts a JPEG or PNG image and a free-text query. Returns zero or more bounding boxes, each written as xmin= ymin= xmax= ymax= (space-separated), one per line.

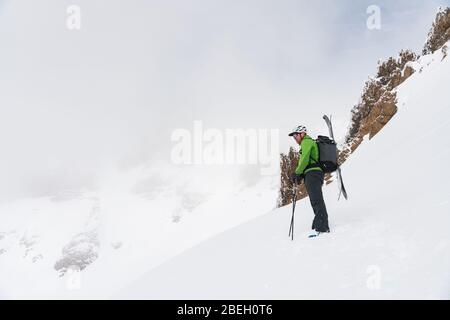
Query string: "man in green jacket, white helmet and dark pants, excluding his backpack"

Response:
xmin=289 ymin=126 xmax=330 ymax=237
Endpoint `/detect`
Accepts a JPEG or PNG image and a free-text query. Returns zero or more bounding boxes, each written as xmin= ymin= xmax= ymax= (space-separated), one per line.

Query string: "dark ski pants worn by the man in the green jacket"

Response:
xmin=305 ymin=170 xmax=330 ymax=232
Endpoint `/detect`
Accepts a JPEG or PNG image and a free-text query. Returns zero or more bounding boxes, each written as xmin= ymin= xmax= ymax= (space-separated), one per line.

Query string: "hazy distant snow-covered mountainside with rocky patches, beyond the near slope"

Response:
xmin=0 ymin=165 xmax=278 ymax=298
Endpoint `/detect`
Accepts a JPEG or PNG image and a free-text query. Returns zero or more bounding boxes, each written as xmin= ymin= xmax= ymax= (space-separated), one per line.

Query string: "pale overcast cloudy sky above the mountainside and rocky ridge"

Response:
xmin=0 ymin=0 xmax=450 ymax=199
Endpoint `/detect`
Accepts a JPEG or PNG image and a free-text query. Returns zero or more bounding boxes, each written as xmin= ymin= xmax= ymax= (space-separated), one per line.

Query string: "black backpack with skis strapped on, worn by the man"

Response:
xmin=305 ymin=115 xmax=347 ymax=200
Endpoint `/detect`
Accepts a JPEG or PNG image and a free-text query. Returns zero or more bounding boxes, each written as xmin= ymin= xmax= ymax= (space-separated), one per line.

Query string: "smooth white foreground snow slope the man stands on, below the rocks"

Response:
xmin=118 ymin=43 xmax=450 ymax=299
